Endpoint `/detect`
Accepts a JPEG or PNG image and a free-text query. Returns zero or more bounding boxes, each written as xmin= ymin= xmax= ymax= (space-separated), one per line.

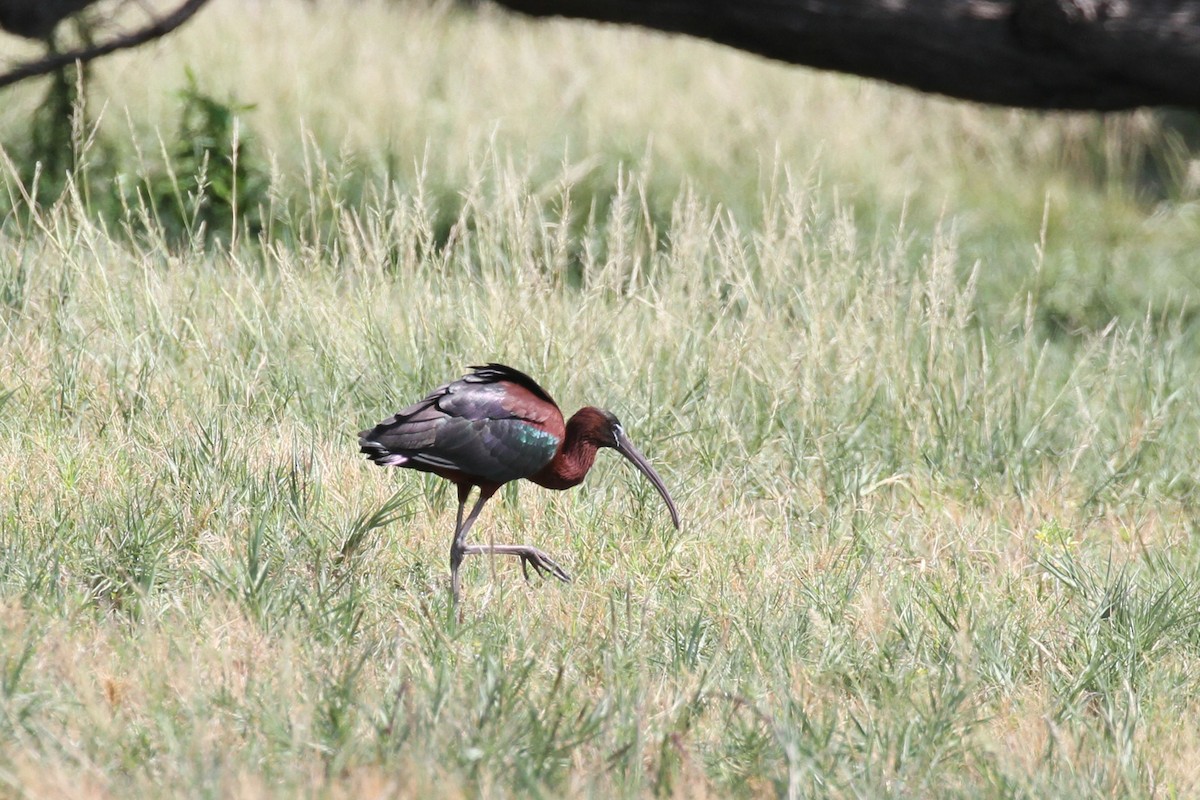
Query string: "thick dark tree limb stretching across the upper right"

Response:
xmin=496 ymin=0 xmax=1200 ymax=110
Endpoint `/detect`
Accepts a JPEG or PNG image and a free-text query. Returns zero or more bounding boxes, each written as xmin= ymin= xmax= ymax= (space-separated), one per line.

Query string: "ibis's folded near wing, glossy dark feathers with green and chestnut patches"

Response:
xmin=359 ymin=367 xmax=559 ymax=485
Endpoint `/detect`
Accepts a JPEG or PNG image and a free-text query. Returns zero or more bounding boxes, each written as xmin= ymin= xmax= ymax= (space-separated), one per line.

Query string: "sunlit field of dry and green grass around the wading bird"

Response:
xmin=0 ymin=0 xmax=1200 ymax=798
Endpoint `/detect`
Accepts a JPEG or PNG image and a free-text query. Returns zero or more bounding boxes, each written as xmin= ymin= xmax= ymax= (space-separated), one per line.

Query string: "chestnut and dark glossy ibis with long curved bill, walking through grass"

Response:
xmin=359 ymin=362 xmax=679 ymax=603
